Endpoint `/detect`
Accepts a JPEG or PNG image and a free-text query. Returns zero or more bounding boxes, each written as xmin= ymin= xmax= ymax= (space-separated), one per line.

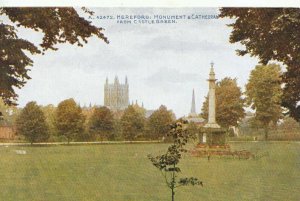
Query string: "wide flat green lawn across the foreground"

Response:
xmin=0 ymin=142 xmax=300 ymax=201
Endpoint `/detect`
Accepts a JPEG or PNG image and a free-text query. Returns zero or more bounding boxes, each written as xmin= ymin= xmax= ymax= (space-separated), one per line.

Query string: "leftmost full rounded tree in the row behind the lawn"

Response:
xmin=16 ymin=102 xmax=49 ymax=144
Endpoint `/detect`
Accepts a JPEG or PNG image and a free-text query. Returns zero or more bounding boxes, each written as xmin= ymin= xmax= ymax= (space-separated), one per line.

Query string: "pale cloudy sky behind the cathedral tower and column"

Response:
xmin=9 ymin=8 xmax=258 ymax=117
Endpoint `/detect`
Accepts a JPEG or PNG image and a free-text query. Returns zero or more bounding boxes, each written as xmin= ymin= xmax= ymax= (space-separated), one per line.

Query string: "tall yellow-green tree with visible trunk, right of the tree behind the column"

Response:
xmin=246 ymin=64 xmax=282 ymax=140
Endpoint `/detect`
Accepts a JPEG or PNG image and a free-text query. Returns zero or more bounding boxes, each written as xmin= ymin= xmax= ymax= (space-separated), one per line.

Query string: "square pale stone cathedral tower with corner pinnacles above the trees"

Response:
xmin=104 ymin=76 xmax=129 ymax=111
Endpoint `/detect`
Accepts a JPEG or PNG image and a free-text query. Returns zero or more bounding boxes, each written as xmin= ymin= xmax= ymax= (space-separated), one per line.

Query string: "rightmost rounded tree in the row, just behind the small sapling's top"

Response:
xmin=148 ymin=105 xmax=173 ymax=139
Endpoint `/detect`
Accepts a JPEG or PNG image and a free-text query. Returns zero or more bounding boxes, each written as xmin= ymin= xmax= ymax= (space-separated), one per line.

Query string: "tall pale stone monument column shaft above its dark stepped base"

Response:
xmin=204 ymin=62 xmax=220 ymax=128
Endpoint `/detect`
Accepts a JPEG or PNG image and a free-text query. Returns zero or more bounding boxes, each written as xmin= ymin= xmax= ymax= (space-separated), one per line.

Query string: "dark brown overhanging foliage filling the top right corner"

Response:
xmin=220 ymin=8 xmax=300 ymax=121
